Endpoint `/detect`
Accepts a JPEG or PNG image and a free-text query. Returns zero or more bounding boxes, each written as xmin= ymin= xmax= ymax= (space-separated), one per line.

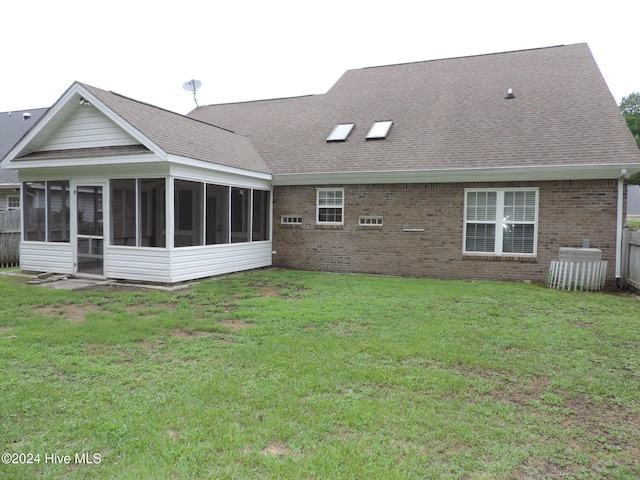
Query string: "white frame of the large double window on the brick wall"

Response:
xmin=462 ymin=187 xmax=540 ymax=257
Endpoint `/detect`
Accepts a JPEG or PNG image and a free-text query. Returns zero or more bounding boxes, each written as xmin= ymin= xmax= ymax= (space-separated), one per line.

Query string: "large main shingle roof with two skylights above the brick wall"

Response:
xmin=189 ymin=44 xmax=640 ymax=174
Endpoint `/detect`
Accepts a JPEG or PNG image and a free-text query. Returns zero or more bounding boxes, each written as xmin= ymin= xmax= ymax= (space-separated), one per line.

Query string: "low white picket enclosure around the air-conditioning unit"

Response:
xmin=547 ymin=260 xmax=607 ymax=292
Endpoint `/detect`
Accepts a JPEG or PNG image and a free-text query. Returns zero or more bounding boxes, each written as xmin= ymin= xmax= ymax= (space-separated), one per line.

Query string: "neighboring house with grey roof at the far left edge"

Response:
xmin=0 ymin=108 xmax=47 ymax=231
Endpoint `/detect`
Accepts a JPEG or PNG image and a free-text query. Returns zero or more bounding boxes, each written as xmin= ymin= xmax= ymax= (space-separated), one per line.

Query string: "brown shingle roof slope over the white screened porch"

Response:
xmin=80 ymin=84 xmax=269 ymax=173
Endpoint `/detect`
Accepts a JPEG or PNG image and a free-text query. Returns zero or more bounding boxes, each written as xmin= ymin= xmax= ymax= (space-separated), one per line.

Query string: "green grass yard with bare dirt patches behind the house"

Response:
xmin=0 ymin=270 xmax=640 ymax=479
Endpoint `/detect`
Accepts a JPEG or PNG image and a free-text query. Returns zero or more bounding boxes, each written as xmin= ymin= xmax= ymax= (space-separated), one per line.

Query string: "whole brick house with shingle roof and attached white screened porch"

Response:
xmin=3 ymin=44 xmax=640 ymax=282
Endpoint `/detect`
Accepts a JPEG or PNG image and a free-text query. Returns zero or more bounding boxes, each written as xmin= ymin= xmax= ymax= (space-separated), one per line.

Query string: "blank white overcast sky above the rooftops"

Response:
xmin=0 ymin=0 xmax=640 ymax=114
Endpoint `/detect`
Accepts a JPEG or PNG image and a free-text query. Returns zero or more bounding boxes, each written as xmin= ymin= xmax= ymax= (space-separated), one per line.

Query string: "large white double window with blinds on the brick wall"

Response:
xmin=464 ymin=188 xmax=538 ymax=255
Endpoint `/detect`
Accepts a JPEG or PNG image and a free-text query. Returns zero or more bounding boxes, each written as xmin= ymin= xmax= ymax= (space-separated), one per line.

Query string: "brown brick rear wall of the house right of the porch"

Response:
xmin=273 ymin=180 xmax=617 ymax=283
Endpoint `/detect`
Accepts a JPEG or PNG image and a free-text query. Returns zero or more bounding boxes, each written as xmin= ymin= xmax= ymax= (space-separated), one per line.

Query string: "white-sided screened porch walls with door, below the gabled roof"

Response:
xmin=21 ymin=176 xmax=271 ymax=283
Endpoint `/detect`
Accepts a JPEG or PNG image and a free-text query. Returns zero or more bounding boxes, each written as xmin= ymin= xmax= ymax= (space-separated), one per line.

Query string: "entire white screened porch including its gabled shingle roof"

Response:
xmin=7 ymin=82 xmax=272 ymax=283
